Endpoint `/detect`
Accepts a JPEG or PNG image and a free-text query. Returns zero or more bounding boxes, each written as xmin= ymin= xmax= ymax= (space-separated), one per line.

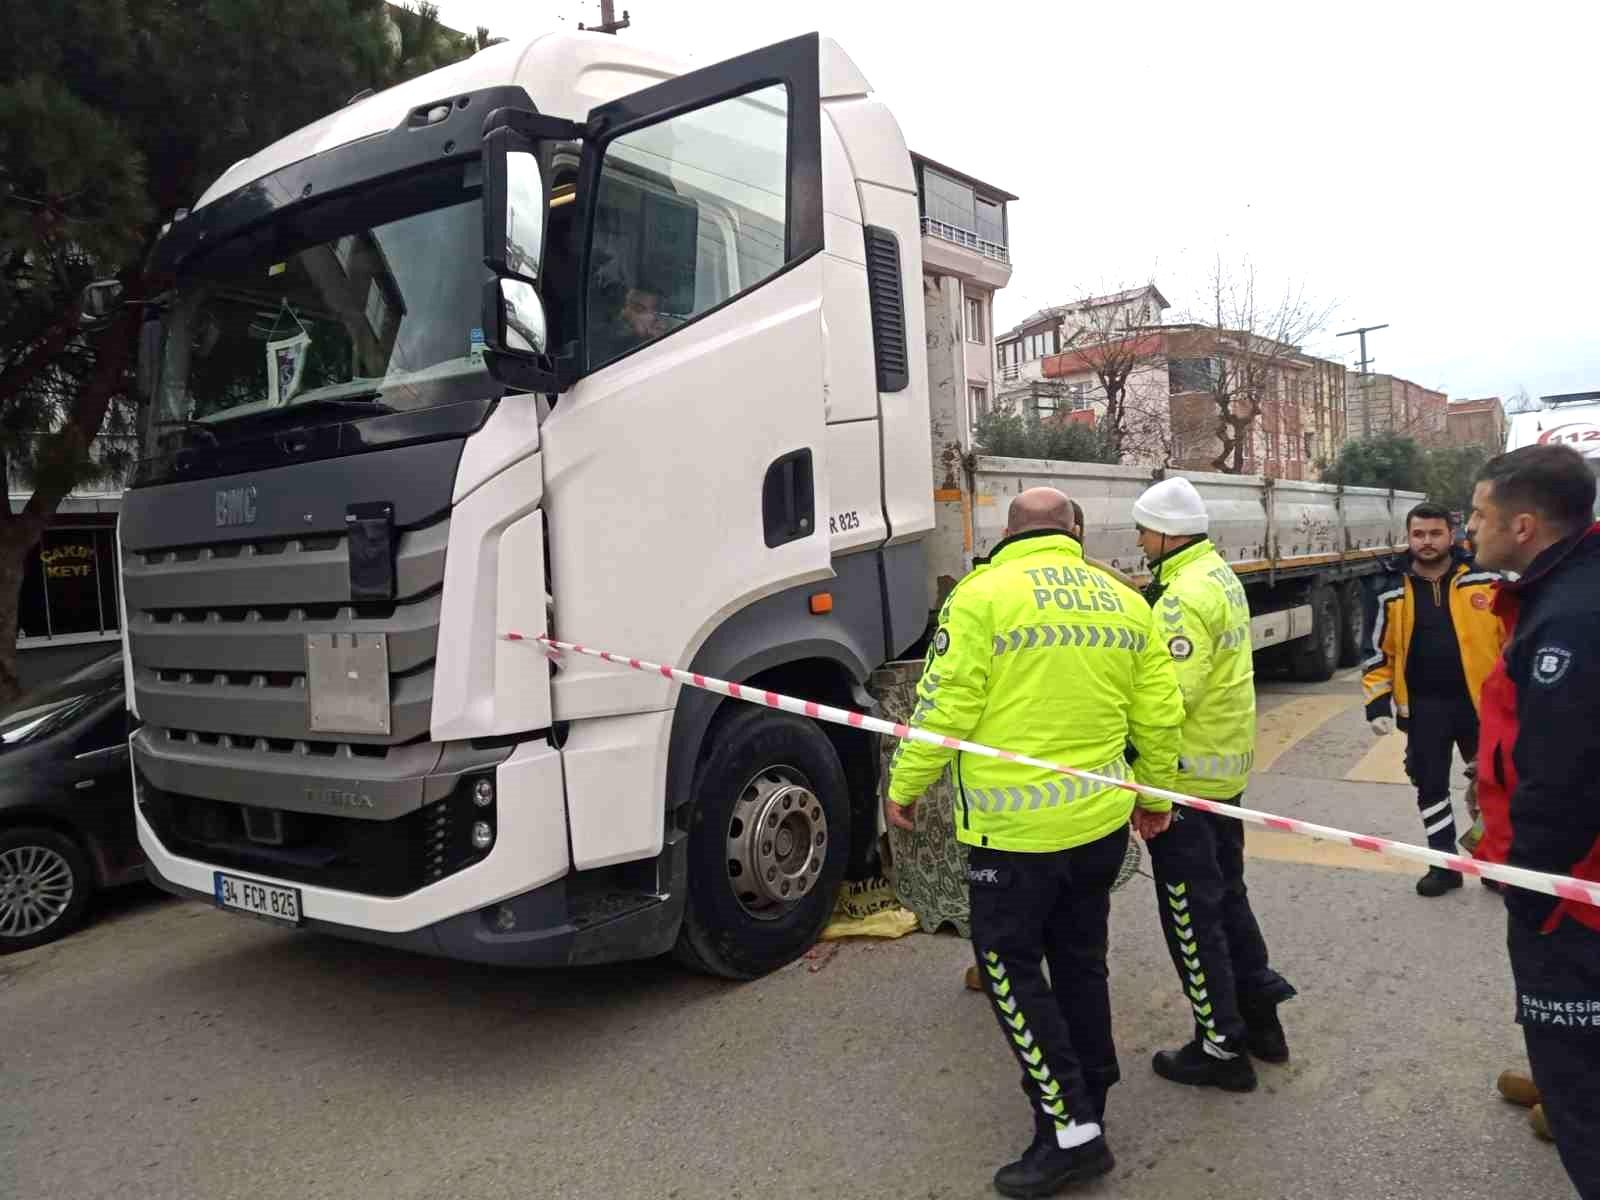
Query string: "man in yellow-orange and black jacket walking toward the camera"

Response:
xmin=1363 ymin=504 xmax=1501 ymax=896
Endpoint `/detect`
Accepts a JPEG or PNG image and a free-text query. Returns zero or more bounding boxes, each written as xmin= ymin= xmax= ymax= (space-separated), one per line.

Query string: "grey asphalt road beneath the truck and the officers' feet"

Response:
xmin=0 ymin=674 xmax=1573 ymax=1200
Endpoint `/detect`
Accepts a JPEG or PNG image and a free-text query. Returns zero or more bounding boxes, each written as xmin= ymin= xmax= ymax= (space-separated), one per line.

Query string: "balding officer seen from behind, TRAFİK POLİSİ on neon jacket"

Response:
xmin=885 ymin=488 xmax=1182 ymax=1195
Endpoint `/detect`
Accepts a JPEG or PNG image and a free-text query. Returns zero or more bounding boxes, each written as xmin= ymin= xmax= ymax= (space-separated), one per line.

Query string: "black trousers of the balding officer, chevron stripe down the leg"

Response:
xmin=966 ymin=827 xmax=1128 ymax=1130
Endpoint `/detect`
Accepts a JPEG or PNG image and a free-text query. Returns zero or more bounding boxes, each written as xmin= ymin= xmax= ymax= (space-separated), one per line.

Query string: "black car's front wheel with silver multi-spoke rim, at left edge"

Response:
xmin=0 ymin=827 xmax=94 ymax=954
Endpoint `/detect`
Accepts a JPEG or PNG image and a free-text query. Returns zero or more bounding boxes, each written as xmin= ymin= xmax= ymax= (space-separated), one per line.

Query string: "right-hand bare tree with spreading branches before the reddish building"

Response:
xmin=1173 ymin=258 xmax=1333 ymax=475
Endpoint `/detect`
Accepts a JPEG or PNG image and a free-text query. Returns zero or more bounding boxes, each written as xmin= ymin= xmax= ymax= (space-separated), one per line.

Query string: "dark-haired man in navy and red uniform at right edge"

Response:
xmin=1470 ymin=445 xmax=1600 ymax=1200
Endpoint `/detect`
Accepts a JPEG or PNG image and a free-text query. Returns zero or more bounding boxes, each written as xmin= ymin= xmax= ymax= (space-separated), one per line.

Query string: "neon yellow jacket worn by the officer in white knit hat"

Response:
xmin=1146 ymin=538 xmax=1256 ymax=800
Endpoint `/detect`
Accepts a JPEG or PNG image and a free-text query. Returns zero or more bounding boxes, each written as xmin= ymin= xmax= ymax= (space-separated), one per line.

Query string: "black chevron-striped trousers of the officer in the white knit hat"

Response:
xmin=1149 ymin=795 xmax=1294 ymax=1053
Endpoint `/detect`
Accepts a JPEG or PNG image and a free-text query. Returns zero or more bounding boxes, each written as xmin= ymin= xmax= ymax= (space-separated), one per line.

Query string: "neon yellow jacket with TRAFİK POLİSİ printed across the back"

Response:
xmin=888 ymin=531 xmax=1182 ymax=853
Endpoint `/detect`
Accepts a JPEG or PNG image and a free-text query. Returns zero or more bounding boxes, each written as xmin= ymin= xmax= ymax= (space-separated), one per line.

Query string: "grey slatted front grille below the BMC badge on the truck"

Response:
xmin=123 ymin=520 xmax=450 ymax=755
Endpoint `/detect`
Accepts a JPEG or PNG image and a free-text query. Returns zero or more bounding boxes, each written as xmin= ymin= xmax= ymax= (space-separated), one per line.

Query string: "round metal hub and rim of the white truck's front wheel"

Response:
xmin=728 ymin=766 xmax=827 ymax=918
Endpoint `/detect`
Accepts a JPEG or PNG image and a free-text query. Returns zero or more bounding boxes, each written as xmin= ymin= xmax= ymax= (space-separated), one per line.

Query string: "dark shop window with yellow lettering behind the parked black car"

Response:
xmin=16 ymin=525 xmax=122 ymax=642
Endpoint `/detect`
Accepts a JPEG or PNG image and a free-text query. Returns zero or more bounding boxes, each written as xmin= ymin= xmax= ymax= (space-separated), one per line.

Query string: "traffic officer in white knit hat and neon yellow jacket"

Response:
xmin=1133 ymin=478 xmax=1294 ymax=1091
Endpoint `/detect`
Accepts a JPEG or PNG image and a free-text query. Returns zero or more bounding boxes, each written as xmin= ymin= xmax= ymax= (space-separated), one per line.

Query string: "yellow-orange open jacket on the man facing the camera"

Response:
xmin=1362 ymin=555 xmax=1504 ymax=730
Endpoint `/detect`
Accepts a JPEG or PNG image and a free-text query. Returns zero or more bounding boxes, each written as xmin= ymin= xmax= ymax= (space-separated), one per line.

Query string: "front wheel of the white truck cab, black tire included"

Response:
xmin=674 ymin=709 xmax=850 ymax=979
